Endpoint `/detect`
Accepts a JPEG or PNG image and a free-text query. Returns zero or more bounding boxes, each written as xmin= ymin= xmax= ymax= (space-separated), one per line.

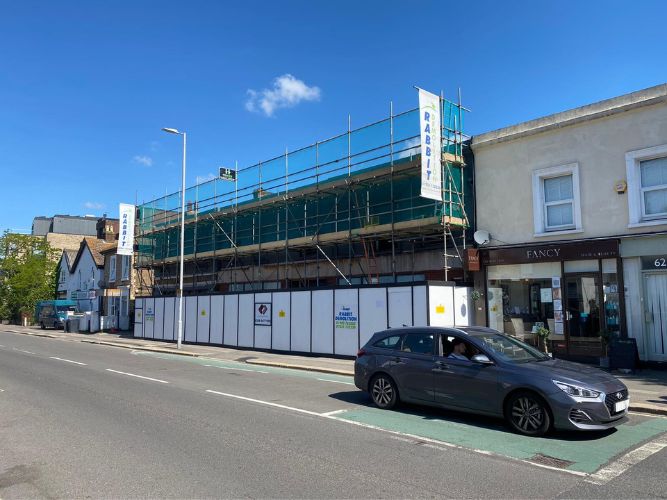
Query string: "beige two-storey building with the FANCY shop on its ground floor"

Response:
xmin=472 ymin=84 xmax=667 ymax=361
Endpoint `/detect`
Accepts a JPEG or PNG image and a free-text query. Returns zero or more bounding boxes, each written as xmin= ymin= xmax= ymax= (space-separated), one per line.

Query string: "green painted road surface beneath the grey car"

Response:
xmin=336 ymin=407 xmax=667 ymax=473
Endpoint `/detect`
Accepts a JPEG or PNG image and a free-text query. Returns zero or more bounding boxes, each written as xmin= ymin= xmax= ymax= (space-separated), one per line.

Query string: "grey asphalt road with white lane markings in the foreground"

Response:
xmin=0 ymin=332 xmax=667 ymax=499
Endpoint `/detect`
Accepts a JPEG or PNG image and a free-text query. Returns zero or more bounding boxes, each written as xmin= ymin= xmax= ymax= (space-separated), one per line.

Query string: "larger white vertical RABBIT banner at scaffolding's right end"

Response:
xmin=419 ymin=89 xmax=442 ymax=201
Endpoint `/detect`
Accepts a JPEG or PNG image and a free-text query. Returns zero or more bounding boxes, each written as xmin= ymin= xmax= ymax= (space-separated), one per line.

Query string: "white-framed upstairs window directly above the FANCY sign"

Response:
xmin=533 ymin=163 xmax=581 ymax=235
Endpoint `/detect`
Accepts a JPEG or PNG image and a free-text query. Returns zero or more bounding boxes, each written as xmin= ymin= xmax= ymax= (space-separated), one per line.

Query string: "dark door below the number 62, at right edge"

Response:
xmin=644 ymin=273 xmax=667 ymax=361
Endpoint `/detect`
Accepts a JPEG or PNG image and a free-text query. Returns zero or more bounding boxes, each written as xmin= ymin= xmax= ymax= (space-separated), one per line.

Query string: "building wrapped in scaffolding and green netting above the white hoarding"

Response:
xmin=136 ymin=93 xmax=473 ymax=296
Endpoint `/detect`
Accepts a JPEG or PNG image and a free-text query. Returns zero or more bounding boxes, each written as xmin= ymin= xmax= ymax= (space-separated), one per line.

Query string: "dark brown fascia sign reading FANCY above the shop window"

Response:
xmin=482 ymin=240 xmax=618 ymax=266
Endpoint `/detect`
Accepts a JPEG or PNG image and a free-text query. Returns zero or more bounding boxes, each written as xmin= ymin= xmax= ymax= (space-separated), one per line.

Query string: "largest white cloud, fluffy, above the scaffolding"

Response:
xmin=245 ymin=73 xmax=322 ymax=116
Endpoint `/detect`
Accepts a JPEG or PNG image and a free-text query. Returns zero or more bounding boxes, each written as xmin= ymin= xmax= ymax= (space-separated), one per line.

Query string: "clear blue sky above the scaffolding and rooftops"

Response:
xmin=0 ymin=0 xmax=667 ymax=231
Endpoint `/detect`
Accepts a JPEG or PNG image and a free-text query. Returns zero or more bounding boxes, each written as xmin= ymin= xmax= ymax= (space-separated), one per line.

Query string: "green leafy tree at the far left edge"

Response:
xmin=0 ymin=232 xmax=60 ymax=322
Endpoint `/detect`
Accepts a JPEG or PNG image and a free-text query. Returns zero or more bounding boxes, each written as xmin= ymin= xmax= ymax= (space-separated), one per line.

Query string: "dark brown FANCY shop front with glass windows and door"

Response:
xmin=481 ymin=240 xmax=625 ymax=359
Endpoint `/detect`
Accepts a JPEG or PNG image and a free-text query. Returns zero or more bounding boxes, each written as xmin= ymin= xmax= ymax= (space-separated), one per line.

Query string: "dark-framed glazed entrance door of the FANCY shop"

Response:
xmin=563 ymin=273 xmax=603 ymax=357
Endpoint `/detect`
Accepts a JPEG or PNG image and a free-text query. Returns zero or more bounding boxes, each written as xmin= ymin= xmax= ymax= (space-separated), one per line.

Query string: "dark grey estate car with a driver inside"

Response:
xmin=354 ymin=327 xmax=629 ymax=436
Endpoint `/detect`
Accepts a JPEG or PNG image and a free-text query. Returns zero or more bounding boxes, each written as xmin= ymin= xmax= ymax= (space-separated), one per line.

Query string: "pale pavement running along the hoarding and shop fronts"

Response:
xmin=0 ymin=325 xmax=667 ymax=416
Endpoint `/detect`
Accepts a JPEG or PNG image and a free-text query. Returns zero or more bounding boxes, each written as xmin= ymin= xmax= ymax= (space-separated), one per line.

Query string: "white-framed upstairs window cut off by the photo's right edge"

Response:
xmin=625 ymin=144 xmax=667 ymax=227
